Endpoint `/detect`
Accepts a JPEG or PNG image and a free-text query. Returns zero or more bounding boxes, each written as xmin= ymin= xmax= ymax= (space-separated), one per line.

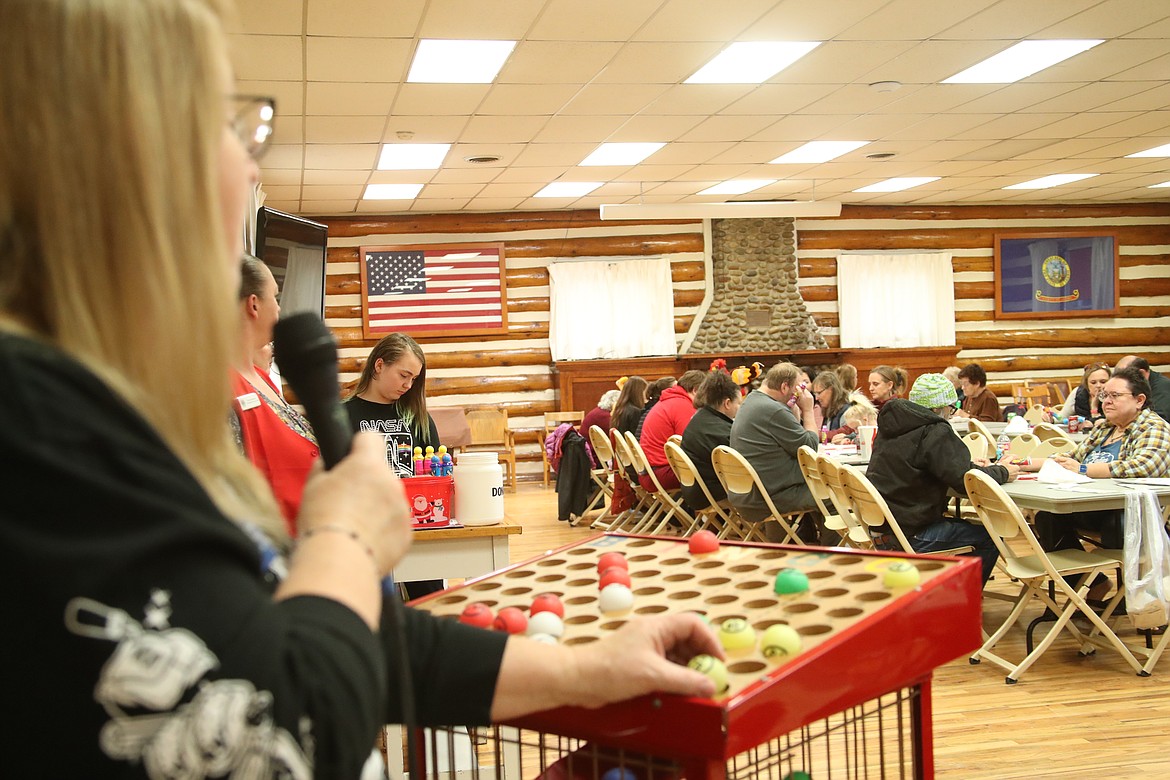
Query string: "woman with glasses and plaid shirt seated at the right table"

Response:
xmin=1023 ymin=368 xmax=1170 ymax=558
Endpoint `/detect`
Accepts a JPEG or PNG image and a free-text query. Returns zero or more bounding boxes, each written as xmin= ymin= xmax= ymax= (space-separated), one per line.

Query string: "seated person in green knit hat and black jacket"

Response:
xmin=866 ymin=374 xmax=1019 ymax=584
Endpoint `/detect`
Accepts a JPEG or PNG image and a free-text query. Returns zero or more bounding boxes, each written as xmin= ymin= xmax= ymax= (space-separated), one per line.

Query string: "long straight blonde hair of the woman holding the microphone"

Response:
xmin=0 ymin=0 xmax=281 ymax=547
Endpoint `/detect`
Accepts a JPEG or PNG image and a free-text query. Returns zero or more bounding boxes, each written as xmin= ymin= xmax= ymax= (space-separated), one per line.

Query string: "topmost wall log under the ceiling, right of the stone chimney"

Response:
xmin=834 ymin=202 xmax=1170 ymax=221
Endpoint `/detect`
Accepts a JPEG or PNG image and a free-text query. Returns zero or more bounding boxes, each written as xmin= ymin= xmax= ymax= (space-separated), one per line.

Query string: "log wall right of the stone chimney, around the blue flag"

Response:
xmin=797 ymin=203 xmax=1170 ymax=401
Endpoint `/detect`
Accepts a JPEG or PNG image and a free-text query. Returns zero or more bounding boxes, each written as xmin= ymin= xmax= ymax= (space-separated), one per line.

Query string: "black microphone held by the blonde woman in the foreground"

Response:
xmin=273 ymin=311 xmax=353 ymax=469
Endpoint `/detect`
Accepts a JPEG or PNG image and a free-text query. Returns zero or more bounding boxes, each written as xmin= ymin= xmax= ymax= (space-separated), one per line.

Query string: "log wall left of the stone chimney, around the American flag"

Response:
xmin=314 ymin=210 xmax=706 ymax=477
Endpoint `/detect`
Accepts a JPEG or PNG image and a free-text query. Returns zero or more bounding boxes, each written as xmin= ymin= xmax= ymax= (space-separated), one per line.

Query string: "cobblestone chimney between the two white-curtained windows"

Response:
xmin=689 ymin=218 xmax=828 ymax=353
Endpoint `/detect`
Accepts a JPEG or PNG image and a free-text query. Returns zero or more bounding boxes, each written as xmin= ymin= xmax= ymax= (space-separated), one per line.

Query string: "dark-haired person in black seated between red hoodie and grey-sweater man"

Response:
xmin=681 ymin=371 xmax=743 ymax=510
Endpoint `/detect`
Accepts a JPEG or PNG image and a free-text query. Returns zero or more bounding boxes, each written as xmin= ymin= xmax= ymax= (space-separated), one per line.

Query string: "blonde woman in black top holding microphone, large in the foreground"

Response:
xmin=0 ymin=0 xmax=722 ymax=778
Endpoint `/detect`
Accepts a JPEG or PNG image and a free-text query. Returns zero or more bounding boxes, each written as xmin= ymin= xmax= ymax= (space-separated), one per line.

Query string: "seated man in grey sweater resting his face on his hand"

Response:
xmin=729 ymin=363 xmax=835 ymax=543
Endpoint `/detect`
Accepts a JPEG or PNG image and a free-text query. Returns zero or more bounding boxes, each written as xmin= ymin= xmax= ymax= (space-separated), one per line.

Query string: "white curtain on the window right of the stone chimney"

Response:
xmin=837 ymin=251 xmax=955 ymax=348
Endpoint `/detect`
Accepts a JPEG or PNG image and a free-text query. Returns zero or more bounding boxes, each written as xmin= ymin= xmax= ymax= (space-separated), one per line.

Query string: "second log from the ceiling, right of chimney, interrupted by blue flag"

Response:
xmin=797 ymin=225 xmax=1170 ymax=250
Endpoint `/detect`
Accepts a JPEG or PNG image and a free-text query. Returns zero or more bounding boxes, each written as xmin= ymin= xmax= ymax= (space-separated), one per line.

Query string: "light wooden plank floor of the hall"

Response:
xmin=504 ymin=483 xmax=1170 ymax=780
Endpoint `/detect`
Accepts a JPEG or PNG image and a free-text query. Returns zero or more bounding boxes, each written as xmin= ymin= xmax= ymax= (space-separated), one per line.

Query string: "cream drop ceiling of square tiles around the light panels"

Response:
xmin=225 ymin=0 xmax=1170 ymax=215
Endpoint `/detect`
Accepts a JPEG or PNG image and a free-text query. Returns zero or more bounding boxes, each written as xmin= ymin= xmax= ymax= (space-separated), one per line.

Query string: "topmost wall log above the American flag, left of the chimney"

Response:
xmin=314 ymin=208 xmax=702 ymax=243
